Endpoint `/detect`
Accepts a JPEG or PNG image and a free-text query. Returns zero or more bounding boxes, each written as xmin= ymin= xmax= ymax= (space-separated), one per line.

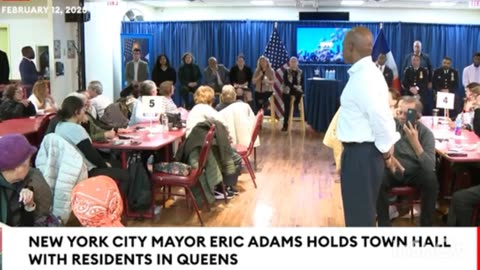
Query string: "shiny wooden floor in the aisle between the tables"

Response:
xmin=128 ymin=122 xmax=442 ymax=227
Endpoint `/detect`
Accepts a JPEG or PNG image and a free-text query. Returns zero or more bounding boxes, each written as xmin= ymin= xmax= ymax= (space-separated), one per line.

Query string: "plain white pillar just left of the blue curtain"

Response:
xmin=85 ymin=1 xmax=156 ymax=98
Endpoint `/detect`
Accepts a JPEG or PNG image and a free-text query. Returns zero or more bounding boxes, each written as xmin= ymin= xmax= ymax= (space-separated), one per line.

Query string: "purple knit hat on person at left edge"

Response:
xmin=0 ymin=134 xmax=37 ymax=171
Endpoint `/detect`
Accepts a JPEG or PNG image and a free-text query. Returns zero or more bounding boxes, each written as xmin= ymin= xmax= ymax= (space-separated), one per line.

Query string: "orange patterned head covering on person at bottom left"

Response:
xmin=71 ymin=175 xmax=123 ymax=227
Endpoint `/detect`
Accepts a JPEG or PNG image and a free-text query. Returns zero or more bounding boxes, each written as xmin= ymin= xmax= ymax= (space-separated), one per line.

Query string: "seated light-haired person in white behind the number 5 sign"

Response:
xmin=128 ymin=80 xmax=160 ymax=126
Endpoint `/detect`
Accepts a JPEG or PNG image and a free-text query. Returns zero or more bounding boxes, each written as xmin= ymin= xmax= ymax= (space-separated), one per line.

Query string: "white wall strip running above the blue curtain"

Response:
xmin=156 ymin=7 xmax=480 ymax=24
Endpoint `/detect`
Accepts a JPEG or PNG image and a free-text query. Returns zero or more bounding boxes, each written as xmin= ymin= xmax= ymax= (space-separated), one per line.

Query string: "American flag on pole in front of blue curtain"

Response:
xmin=263 ymin=27 xmax=289 ymax=116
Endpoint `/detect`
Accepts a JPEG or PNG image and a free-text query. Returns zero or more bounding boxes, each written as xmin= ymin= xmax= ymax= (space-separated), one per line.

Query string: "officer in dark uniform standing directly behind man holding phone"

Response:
xmin=402 ymin=55 xmax=431 ymax=115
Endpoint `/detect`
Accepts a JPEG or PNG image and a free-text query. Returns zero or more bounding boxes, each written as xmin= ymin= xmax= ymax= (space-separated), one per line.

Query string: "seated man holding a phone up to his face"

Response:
xmin=377 ymin=96 xmax=438 ymax=226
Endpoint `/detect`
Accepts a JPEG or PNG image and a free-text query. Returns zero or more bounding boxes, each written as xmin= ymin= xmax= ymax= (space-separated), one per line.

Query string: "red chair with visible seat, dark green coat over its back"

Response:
xmin=152 ymin=124 xmax=215 ymax=226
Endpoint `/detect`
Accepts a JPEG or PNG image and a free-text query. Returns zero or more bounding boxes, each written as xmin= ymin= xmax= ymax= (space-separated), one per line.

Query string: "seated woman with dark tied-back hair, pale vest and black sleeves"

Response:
xmin=55 ymin=96 xmax=129 ymax=191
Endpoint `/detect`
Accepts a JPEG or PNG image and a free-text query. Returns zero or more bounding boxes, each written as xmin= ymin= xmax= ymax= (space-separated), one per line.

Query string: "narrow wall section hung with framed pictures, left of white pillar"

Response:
xmin=50 ymin=0 xmax=78 ymax=104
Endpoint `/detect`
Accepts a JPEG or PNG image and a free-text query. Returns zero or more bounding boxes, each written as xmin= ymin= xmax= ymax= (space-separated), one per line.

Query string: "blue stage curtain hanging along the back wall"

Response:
xmin=122 ymin=21 xmax=480 ymax=104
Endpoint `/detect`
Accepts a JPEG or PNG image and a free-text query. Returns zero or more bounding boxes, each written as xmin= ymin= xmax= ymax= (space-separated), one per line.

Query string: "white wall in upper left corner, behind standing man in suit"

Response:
xmin=0 ymin=0 xmax=52 ymax=80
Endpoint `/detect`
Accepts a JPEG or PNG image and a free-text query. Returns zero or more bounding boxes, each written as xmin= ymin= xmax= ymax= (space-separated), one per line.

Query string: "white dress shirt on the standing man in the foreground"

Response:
xmin=337 ymin=56 xmax=400 ymax=153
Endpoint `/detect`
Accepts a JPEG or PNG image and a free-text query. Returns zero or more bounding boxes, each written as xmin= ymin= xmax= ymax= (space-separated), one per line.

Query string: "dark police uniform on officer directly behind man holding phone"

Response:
xmin=402 ymin=66 xmax=431 ymax=115
